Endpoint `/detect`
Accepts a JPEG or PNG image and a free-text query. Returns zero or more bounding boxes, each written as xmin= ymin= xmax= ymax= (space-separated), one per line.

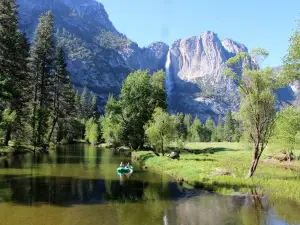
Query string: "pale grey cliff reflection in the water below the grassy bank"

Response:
xmin=167 ymin=190 xmax=269 ymax=225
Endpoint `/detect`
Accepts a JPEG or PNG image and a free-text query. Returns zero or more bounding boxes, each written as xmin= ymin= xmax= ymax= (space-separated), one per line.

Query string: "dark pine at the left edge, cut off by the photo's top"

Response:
xmin=0 ymin=0 xmax=29 ymax=145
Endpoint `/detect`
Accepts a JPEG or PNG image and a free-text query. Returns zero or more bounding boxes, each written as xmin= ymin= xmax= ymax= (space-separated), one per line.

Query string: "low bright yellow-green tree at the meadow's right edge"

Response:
xmin=273 ymin=106 xmax=300 ymax=159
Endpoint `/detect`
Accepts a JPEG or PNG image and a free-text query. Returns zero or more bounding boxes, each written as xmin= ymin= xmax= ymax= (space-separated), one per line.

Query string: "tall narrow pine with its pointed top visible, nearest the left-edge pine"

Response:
xmin=30 ymin=12 xmax=54 ymax=145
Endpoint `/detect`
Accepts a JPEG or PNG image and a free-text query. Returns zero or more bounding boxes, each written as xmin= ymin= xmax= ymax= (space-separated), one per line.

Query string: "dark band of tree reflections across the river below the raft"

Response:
xmin=0 ymin=176 xmax=177 ymax=205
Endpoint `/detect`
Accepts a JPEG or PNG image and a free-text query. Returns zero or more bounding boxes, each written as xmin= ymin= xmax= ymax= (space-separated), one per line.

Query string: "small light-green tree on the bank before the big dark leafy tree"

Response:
xmin=144 ymin=108 xmax=176 ymax=156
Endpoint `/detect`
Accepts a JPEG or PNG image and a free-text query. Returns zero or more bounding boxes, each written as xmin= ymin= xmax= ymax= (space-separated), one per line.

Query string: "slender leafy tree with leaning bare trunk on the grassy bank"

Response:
xmin=225 ymin=49 xmax=277 ymax=177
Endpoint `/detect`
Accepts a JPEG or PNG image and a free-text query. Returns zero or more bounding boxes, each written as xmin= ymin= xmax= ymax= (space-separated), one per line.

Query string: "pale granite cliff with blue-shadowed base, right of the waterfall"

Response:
xmin=170 ymin=31 xmax=248 ymax=119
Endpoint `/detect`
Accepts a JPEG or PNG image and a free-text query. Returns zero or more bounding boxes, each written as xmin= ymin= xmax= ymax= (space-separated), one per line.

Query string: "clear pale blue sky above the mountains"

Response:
xmin=99 ymin=0 xmax=300 ymax=66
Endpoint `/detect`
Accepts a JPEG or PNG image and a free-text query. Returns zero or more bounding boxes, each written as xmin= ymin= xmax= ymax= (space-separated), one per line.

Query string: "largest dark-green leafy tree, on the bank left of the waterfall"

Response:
xmin=105 ymin=70 xmax=166 ymax=149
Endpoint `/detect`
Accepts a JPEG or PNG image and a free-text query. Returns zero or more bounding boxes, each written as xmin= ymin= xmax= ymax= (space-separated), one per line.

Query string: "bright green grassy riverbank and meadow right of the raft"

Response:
xmin=132 ymin=143 xmax=300 ymax=204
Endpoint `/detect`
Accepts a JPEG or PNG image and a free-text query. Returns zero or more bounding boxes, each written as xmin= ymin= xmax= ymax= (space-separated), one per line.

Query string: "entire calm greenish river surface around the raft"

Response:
xmin=0 ymin=145 xmax=300 ymax=225
